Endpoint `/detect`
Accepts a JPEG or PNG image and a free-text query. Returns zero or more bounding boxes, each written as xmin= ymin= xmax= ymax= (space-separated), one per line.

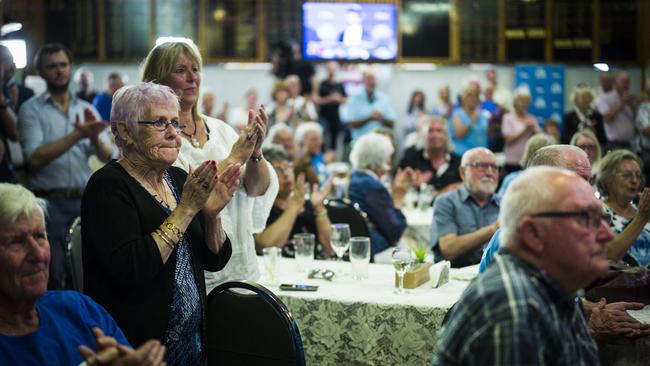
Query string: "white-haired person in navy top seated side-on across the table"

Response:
xmin=348 ymin=133 xmax=408 ymax=255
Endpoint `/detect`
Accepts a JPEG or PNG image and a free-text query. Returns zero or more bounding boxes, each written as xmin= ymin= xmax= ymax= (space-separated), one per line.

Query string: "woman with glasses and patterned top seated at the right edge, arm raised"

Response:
xmin=596 ymin=150 xmax=650 ymax=268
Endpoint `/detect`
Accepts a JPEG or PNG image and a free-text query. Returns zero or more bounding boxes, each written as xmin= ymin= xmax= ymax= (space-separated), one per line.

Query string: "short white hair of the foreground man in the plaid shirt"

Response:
xmin=499 ymin=166 xmax=577 ymax=247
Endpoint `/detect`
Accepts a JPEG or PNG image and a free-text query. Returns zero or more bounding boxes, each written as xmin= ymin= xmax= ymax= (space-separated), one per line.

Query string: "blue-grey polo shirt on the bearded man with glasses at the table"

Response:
xmin=431 ymin=184 xmax=499 ymax=267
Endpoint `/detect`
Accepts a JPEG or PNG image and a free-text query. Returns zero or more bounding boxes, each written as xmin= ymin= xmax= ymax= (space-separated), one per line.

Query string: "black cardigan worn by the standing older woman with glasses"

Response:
xmin=81 ymin=161 xmax=232 ymax=350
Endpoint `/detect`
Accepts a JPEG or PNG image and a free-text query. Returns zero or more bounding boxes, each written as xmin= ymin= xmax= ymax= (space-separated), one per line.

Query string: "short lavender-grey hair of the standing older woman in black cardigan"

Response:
xmin=111 ymin=82 xmax=181 ymax=151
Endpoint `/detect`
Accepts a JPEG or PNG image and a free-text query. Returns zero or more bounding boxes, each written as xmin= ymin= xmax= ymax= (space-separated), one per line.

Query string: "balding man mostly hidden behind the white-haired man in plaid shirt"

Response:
xmin=479 ymin=143 xmax=591 ymax=273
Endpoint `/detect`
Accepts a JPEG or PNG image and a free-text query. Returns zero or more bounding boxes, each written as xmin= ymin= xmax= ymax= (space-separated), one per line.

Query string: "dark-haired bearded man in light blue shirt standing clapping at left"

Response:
xmin=18 ymin=44 xmax=113 ymax=289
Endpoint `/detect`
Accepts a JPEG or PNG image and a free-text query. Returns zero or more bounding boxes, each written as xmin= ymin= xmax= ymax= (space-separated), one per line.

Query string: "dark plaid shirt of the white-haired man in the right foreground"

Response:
xmin=433 ymin=250 xmax=600 ymax=365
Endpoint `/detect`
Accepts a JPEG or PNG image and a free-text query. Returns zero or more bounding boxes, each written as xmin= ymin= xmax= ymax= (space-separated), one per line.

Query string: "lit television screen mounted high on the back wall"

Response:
xmin=302 ymin=2 xmax=397 ymax=61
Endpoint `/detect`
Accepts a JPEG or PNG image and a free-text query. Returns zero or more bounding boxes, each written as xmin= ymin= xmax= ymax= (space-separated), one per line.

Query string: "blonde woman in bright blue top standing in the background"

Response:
xmin=450 ymin=83 xmax=489 ymax=156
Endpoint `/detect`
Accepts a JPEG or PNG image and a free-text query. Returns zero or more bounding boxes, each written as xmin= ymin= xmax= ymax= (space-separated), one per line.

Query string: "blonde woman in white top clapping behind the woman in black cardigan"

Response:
xmin=142 ymin=39 xmax=278 ymax=291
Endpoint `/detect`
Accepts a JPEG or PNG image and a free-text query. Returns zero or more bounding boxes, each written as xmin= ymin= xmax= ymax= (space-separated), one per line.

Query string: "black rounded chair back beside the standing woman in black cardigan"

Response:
xmin=206 ymin=280 xmax=306 ymax=366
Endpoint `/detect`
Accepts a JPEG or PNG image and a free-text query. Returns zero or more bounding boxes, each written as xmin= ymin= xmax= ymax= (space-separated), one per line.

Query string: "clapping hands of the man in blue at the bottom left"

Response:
xmin=79 ymin=327 xmax=166 ymax=366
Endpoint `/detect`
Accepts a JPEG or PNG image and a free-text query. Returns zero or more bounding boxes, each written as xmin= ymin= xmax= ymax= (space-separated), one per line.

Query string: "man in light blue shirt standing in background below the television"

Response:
xmin=344 ymin=71 xmax=396 ymax=141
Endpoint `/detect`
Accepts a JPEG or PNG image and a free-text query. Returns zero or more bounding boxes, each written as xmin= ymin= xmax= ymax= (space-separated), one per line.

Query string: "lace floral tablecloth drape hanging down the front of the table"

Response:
xmin=278 ymin=293 xmax=448 ymax=366
